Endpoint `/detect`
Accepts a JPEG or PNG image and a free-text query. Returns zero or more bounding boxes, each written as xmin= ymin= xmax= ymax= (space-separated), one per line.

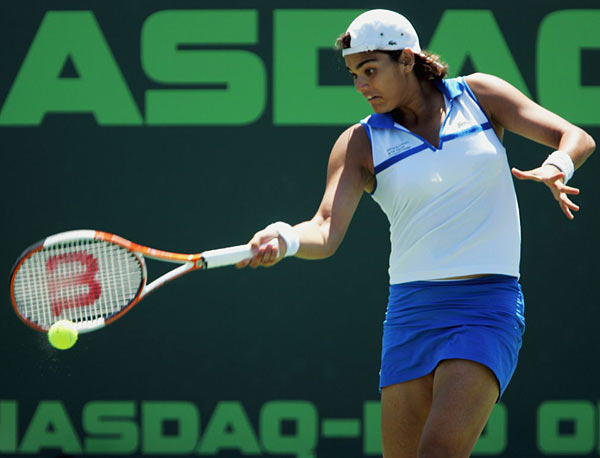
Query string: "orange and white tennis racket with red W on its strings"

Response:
xmin=10 ymin=230 xmax=279 ymax=333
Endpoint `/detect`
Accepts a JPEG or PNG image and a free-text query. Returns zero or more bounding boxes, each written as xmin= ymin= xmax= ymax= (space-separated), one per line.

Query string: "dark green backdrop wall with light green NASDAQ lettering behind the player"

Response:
xmin=0 ymin=0 xmax=600 ymax=458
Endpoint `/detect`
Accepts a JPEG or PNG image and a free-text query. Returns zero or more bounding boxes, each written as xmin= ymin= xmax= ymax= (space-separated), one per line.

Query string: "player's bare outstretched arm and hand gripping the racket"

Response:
xmin=238 ymin=124 xmax=374 ymax=267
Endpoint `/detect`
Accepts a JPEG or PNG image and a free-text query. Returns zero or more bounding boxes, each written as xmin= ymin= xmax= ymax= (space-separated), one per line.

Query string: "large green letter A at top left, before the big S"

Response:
xmin=0 ymin=11 xmax=142 ymax=126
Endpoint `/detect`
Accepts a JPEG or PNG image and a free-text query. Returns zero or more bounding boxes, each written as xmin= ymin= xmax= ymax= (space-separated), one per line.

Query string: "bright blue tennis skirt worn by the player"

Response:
xmin=380 ymin=275 xmax=525 ymax=396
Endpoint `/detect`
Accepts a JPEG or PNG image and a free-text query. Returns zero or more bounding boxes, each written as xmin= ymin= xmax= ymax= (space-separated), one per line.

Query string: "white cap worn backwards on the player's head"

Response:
xmin=342 ymin=10 xmax=421 ymax=56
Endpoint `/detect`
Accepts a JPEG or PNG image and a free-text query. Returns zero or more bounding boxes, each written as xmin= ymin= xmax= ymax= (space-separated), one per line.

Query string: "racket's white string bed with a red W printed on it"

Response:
xmin=13 ymin=240 xmax=144 ymax=328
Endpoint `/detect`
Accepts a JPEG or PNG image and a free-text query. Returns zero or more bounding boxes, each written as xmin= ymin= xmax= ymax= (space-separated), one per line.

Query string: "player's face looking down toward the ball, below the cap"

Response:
xmin=344 ymin=52 xmax=407 ymax=113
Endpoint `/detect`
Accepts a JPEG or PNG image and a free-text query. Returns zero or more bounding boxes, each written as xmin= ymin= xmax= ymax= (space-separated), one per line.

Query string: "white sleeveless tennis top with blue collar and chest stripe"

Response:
xmin=361 ymin=78 xmax=521 ymax=284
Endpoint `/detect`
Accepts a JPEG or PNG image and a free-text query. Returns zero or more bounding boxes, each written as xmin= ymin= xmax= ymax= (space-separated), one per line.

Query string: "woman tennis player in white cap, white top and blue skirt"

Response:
xmin=239 ymin=10 xmax=595 ymax=458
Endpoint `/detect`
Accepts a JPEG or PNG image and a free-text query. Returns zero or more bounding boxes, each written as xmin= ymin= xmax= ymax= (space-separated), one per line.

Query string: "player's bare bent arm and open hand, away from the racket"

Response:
xmin=466 ymin=73 xmax=596 ymax=219
